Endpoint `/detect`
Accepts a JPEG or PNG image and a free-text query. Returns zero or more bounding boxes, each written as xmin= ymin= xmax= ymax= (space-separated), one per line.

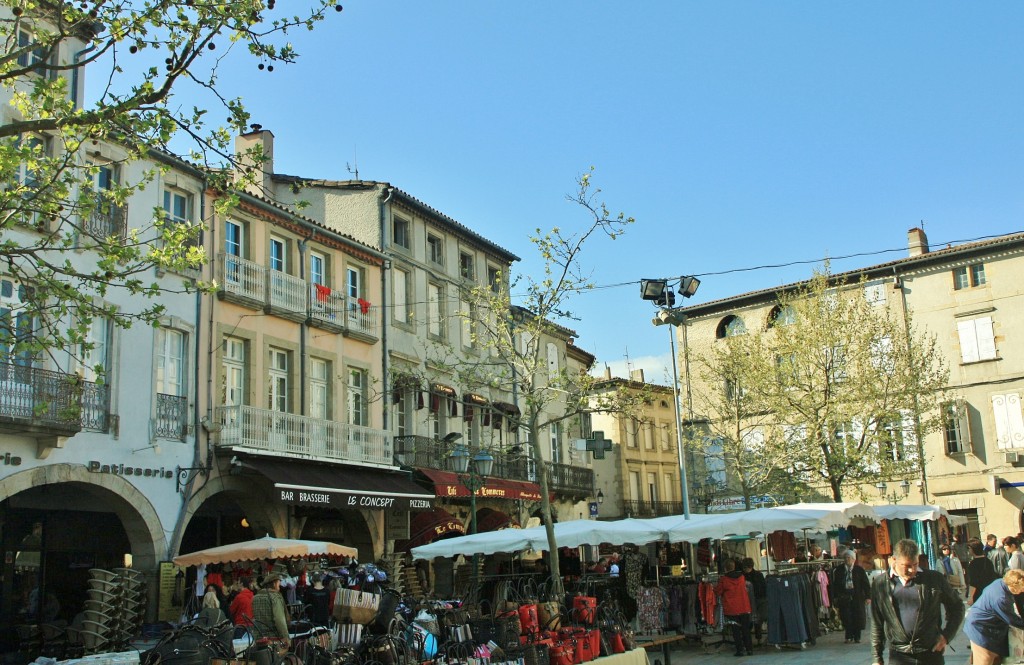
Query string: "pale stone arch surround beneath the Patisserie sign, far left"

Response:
xmin=0 ymin=463 xmax=167 ymax=571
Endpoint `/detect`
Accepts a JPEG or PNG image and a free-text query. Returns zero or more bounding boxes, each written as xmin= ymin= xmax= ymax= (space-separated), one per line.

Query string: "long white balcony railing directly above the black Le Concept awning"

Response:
xmin=217 ymin=406 xmax=394 ymax=466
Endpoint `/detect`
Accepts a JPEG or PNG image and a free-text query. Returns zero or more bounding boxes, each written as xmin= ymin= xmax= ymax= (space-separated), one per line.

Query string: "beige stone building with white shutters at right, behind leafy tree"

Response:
xmin=678 ymin=228 xmax=1024 ymax=537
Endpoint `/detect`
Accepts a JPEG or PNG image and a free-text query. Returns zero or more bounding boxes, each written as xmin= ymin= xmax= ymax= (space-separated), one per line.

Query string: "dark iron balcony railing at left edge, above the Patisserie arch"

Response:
xmin=0 ymin=363 xmax=83 ymax=431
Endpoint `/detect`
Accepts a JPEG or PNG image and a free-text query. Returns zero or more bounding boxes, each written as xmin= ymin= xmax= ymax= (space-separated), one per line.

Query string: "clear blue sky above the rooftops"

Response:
xmin=161 ymin=0 xmax=1024 ymax=383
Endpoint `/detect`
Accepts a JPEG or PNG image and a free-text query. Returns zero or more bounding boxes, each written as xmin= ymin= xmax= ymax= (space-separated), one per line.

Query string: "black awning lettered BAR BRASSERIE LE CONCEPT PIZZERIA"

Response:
xmin=245 ymin=458 xmax=434 ymax=510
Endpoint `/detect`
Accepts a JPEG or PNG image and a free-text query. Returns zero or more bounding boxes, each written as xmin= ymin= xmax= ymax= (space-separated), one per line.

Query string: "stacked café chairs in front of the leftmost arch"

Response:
xmin=68 ymin=568 xmax=145 ymax=655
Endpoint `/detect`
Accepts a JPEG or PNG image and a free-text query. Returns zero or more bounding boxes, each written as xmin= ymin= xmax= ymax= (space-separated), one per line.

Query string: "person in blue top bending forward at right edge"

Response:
xmin=964 ymin=569 xmax=1024 ymax=665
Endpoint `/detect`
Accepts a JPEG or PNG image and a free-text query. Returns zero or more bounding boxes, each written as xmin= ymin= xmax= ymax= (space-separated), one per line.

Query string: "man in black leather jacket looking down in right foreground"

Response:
xmin=871 ymin=540 xmax=964 ymax=665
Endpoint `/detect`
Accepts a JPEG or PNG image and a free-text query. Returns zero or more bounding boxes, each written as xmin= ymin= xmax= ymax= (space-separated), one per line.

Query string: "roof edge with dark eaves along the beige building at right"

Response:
xmin=673 ymin=233 xmax=1024 ymax=317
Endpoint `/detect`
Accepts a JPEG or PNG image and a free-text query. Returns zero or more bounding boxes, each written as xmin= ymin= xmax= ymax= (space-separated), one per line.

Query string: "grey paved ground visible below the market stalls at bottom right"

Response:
xmin=647 ymin=610 xmax=970 ymax=665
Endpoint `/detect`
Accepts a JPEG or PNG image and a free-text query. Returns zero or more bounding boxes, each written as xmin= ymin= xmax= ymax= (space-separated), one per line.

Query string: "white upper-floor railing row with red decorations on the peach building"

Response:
xmin=217 ymin=252 xmax=380 ymax=339
